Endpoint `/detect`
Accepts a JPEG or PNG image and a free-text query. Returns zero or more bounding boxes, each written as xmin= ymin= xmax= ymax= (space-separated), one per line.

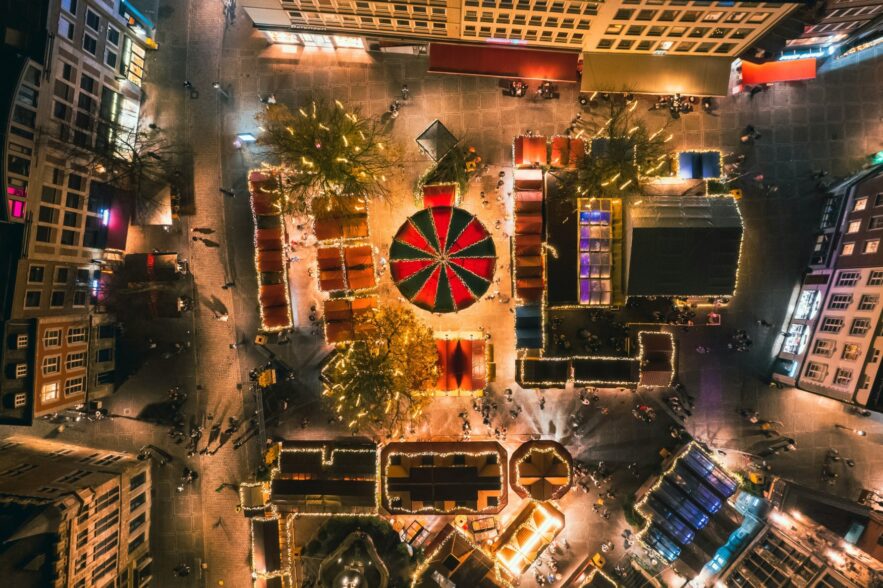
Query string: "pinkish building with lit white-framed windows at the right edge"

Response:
xmin=773 ymin=166 xmax=883 ymax=410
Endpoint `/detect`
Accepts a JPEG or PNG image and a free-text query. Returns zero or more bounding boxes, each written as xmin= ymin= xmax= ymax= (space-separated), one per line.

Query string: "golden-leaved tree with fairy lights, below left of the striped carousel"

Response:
xmin=323 ymin=307 xmax=438 ymax=435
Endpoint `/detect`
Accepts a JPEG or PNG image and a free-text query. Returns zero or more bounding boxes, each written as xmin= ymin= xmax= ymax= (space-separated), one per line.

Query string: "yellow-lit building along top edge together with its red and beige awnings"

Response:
xmin=240 ymin=0 xmax=795 ymax=95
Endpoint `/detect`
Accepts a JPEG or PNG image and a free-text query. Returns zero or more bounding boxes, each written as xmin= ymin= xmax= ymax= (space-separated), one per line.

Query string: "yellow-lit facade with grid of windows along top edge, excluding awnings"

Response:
xmin=240 ymin=0 xmax=793 ymax=56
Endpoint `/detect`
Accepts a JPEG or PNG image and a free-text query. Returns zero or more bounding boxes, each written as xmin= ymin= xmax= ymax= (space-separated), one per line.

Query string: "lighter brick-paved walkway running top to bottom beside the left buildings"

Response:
xmin=142 ymin=1 xmax=255 ymax=586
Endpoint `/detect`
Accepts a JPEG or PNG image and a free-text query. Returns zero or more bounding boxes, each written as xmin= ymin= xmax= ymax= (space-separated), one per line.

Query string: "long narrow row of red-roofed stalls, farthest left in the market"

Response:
xmin=248 ymin=170 xmax=293 ymax=332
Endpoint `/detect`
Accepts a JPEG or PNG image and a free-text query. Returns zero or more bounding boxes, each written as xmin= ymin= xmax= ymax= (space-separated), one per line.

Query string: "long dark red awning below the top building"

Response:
xmin=429 ymin=43 xmax=579 ymax=82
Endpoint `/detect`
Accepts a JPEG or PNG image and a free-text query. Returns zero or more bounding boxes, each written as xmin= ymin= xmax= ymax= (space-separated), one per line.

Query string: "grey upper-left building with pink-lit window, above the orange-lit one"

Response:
xmin=0 ymin=0 xmax=148 ymax=318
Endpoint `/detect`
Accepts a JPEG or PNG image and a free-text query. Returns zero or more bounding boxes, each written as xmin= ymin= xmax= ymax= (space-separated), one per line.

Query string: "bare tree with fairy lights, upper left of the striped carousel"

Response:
xmin=257 ymin=100 xmax=395 ymax=214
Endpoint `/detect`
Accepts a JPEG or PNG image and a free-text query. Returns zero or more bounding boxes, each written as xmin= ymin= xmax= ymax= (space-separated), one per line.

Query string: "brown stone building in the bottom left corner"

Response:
xmin=0 ymin=436 xmax=151 ymax=588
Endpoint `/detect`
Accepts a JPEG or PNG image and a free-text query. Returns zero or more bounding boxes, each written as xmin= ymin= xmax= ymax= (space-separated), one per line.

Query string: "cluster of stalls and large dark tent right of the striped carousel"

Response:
xmin=512 ymin=135 xmax=742 ymax=388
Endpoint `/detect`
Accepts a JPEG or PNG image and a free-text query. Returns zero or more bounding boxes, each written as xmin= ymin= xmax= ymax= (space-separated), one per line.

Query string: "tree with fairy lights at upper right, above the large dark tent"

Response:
xmin=565 ymin=96 xmax=672 ymax=198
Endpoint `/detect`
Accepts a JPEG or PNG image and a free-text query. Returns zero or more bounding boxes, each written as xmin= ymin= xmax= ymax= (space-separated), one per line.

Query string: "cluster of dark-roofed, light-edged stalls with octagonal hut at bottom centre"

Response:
xmin=239 ymin=439 xmax=573 ymax=588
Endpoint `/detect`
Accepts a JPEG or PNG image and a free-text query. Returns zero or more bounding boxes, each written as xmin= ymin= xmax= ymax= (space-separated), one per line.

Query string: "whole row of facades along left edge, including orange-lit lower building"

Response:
xmin=0 ymin=0 xmax=155 ymax=424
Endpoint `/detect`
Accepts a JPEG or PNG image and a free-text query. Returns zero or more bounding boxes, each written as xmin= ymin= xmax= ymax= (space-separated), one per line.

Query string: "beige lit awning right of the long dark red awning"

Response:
xmin=580 ymin=51 xmax=733 ymax=96
